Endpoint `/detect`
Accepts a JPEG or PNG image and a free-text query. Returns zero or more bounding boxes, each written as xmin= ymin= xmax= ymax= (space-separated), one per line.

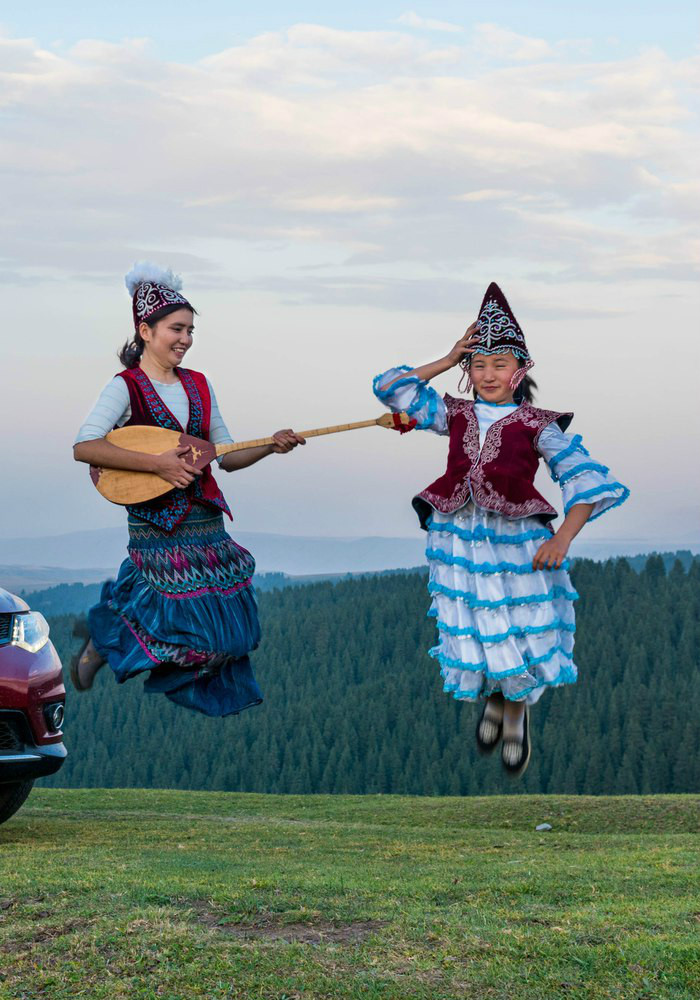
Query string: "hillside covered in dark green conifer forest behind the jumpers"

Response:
xmin=41 ymin=557 xmax=700 ymax=795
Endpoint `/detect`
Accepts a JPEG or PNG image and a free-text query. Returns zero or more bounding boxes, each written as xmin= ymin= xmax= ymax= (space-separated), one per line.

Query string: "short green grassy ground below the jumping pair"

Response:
xmin=0 ymin=790 xmax=700 ymax=1000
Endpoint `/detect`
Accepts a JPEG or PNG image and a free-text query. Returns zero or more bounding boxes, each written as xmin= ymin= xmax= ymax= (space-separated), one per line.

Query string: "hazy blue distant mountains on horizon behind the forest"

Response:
xmin=0 ymin=528 xmax=700 ymax=591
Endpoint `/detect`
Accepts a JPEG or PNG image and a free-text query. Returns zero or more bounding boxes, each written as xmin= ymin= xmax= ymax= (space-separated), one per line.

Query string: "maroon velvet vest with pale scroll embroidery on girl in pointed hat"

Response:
xmin=413 ymin=396 xmax=573 ymax=528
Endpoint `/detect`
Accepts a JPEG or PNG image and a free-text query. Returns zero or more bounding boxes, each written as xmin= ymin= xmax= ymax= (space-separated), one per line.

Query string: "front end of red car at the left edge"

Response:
xmin=0 ymin=587 xmax=66 ymax=823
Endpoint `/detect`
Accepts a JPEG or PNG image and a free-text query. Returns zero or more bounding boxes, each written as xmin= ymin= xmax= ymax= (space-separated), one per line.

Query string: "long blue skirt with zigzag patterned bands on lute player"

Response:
xmin=88 ymin=506 xmax=262 ymax=716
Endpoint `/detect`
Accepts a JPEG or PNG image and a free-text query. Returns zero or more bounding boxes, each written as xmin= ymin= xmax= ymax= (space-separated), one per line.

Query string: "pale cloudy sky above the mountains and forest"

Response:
xmin=0 ymin=0 xmax=700 ymax=544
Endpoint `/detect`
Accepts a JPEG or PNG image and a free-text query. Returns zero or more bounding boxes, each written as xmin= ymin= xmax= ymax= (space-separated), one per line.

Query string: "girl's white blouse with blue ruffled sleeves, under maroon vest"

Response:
xmin=373 ymin=365 xmax=629 ymax=520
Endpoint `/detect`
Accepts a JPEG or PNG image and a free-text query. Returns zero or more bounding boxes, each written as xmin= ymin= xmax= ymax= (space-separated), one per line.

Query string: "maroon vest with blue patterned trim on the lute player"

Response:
xmin=119 ymin=368 xmax=231 ymax=531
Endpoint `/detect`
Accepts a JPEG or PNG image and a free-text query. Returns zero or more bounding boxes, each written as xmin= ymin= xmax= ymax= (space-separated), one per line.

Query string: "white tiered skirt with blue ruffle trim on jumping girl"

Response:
xmin=426 ymin=503 xmax=578 ymax=704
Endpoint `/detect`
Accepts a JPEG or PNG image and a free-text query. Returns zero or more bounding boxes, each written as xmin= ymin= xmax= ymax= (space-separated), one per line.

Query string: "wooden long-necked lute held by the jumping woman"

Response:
xmin=90 ymin=413 xmax=410 ymax=504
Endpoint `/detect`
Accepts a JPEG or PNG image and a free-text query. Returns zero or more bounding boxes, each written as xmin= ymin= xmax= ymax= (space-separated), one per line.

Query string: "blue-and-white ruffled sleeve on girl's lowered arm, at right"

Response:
xmin=537 ymin=423 xmax=630 ymax=521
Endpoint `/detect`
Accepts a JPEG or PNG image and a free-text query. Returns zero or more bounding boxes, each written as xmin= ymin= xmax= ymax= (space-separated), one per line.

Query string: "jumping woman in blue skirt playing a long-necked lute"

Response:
xmin=71 ymin=264 xmax=305 ymax=716
